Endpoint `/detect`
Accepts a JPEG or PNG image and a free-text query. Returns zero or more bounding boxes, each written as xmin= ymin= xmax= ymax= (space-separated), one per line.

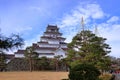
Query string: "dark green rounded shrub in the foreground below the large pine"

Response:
xmin=68 ymin=64 xmax=100 ymax=80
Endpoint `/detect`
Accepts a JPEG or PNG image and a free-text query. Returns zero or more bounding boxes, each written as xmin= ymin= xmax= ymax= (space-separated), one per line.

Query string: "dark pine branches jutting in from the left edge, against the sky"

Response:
xmin=0 ymin=33 xmax=24 ymax=50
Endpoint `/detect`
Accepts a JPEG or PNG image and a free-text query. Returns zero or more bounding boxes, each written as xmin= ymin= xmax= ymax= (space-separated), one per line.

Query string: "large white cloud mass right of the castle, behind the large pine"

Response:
xmin=59 ymin=3 xmax=120 ymax=57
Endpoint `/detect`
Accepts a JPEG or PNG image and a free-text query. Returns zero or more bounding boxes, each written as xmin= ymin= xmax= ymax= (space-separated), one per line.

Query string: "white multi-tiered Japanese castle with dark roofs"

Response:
xmin=14 ymin=25 xmax=68 ymax=58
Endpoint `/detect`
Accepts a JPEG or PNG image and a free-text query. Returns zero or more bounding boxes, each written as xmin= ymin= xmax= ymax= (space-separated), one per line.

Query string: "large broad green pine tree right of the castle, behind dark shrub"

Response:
xmin=67 ymin=30 xmax=111 ymax=69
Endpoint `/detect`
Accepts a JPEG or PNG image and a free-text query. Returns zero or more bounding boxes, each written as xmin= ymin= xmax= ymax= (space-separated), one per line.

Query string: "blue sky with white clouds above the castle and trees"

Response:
xmin=0 ymin=0 xmax=120 ymax=57
